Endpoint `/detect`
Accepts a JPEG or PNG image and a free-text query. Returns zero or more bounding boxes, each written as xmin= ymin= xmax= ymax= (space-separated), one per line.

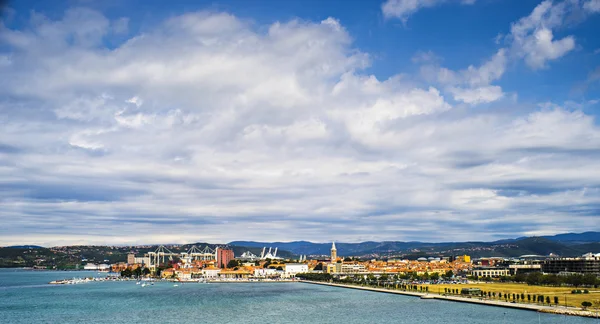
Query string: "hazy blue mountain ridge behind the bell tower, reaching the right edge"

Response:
xmin=229 ymin=232 xmax=600 ymax=257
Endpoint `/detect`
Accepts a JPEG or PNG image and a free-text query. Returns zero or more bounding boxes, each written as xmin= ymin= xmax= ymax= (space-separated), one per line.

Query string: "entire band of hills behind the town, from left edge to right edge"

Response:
xmin=0 ymin=232 xmax=600 ymax=269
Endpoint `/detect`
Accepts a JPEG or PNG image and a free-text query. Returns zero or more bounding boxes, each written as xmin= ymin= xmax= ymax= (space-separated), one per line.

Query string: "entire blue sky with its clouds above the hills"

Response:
xmin=0 ymin=0 xmax=600 ymax=246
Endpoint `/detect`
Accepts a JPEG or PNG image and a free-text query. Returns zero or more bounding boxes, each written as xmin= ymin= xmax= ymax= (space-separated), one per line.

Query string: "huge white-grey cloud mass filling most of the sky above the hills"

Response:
xmin=0 ymin=11 xmax=600 ymax=244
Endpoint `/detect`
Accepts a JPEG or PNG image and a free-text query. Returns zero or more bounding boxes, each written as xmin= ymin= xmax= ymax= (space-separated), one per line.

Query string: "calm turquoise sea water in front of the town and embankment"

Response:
xmin=0 ymin=269 xmax=599 ymax=324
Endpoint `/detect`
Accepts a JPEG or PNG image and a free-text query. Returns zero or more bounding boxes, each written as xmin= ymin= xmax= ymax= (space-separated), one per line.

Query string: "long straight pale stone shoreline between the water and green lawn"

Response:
xmin=298 ymin=280 xmax=598 ymax=318
